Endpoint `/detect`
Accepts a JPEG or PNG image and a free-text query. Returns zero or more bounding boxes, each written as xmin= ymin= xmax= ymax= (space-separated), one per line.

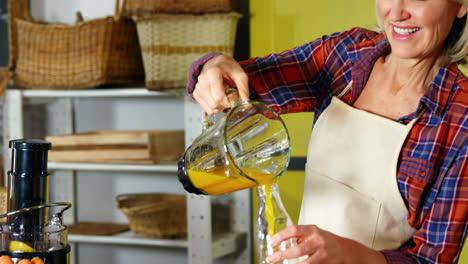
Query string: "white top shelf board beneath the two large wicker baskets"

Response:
xmin=17 ymin=88 xmax=185 ymax=99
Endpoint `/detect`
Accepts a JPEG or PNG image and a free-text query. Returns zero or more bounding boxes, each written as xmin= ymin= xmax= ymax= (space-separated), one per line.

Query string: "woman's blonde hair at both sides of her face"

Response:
xmin=375 ymin=0 xmax=468 ymax=66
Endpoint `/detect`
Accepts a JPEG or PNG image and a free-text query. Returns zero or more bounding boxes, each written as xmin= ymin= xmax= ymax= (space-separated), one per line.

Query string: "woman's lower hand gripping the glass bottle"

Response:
xmin=267 ymin=225 xmax=345 ymax=264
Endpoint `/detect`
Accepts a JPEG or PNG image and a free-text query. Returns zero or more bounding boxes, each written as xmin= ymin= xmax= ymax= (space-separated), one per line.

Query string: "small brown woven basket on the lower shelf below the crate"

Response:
xmin=115 ymin=193 xmax=187 ymax=238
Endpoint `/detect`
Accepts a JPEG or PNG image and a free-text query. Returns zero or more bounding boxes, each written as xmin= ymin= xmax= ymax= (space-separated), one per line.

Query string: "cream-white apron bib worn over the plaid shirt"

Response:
xmin=299 ymin=89 xmax=416 ymax=250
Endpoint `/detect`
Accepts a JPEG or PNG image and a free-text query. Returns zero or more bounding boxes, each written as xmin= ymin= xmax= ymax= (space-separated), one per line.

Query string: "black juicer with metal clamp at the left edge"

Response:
xmin=0 ymin=139 xmax=71 ymax=264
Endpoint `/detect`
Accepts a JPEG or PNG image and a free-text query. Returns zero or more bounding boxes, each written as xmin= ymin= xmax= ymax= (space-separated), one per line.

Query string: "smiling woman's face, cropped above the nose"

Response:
xmin=376 ymin=0 xmax=468 ymax=65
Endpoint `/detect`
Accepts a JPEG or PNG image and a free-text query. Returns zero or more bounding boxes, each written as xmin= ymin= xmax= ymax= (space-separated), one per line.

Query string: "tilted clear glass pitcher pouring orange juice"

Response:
xmin=178 ymin=98 xmax=291 ymax=195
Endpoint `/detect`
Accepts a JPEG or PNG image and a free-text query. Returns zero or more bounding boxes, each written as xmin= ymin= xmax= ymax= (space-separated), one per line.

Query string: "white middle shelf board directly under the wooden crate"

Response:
xmin=48 ymin=162 xmax=177 ymax=172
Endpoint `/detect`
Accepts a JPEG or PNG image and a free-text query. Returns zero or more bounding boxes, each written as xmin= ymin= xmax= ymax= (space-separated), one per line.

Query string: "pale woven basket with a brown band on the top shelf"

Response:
xmin=134 ymin=12 xmax=241 ymax=90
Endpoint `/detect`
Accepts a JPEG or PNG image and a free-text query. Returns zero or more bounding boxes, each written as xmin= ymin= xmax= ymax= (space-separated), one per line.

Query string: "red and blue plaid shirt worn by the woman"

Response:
xmin=187 ymin=28 xmax=468 ymax=263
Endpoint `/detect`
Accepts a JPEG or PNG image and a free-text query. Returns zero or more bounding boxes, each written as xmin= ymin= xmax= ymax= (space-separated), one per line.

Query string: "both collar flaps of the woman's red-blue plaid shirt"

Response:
xmin=346 ymin=34 xmax=460 ymax=117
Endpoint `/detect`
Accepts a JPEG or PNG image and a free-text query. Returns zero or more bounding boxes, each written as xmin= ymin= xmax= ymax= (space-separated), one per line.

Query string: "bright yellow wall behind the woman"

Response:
xmin=250 ymin=0 xmax=468 ymax=264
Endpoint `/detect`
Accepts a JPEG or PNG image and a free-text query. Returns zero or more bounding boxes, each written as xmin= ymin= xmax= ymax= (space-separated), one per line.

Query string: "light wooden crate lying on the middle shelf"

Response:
xmin=45 ymin=130 xmax=185 ymax=164
